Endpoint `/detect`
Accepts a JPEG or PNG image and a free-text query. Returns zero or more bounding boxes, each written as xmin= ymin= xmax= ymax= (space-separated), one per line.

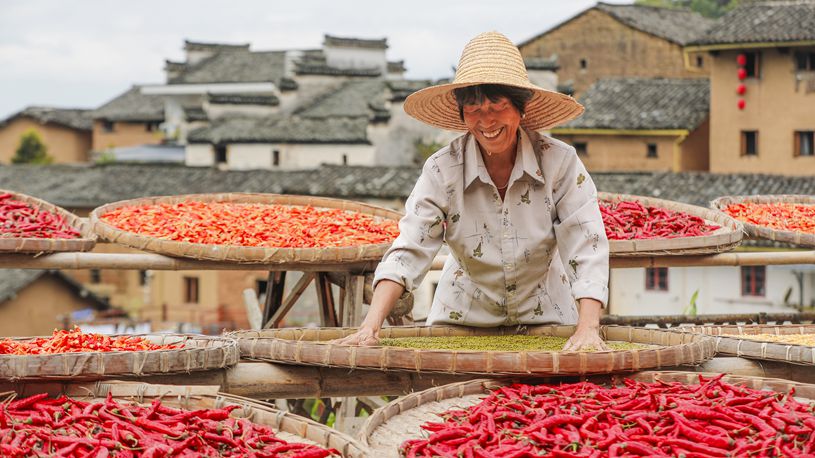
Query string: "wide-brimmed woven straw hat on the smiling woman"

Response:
xmin=405 ymin=32 xmax=583 ymax=131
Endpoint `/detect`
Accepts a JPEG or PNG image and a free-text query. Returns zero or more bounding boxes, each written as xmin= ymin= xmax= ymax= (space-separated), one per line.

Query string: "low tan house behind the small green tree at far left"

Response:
xmin=0 ymin=107 xmax=92 ymax=164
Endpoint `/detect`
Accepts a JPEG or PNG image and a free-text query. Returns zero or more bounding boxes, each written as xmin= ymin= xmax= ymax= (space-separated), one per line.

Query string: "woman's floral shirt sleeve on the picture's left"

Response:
xmin=373 ymin=158 xmax=447 ymax=292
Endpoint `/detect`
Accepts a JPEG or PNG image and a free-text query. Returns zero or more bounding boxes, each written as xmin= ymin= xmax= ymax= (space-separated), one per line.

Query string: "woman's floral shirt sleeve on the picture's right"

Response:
xmin=552 ymin=148 xmax=609 ymax=307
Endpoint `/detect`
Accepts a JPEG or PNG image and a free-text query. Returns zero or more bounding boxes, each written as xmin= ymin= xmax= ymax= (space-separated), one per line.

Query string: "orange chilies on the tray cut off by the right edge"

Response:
xmin=724 ymin=202 xmax=815 ymax=234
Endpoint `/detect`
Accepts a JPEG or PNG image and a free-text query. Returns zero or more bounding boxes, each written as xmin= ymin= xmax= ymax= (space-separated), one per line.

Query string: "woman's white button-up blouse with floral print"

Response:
xmin=374 ymin=129 xmax=608 ymax=327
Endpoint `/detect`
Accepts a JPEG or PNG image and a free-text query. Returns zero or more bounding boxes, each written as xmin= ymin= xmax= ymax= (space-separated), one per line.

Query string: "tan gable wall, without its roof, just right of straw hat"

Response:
xmin=520 ymin=9 xmax=706 ymax=96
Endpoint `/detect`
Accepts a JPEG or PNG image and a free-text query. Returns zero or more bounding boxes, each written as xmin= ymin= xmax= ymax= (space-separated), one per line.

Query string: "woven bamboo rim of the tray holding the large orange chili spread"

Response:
xmin=90 ymin=193 xmax=402 ymax=264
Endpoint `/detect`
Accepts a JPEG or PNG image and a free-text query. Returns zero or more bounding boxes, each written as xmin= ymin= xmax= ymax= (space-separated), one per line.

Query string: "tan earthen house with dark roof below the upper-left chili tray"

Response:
xmin=0 ymin=269 xmax=110 ymax=336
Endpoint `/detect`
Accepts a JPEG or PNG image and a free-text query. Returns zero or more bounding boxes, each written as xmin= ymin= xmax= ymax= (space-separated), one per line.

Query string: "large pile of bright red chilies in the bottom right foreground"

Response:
xmin=401 ymin=376 xmax=815 ymax=458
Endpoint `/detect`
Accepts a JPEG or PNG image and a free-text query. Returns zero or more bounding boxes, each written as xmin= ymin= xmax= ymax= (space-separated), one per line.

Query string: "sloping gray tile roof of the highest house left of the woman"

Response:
xmin=169 ymin=48 xmax=286 ymax=84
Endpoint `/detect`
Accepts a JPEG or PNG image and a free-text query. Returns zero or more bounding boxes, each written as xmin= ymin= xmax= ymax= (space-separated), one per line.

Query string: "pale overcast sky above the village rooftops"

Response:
xmin=0 ymin=0 xmax=630 ymax=119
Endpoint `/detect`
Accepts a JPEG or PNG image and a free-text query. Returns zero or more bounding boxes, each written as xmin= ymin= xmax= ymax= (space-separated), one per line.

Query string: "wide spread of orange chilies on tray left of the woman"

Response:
xmin=102 ymin=201 xmax=399 ymax=248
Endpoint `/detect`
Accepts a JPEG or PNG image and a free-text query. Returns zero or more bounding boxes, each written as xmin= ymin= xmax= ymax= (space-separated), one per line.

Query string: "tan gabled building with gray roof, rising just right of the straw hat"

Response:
xmin=518 ymin=2 xmax=713 ymax=97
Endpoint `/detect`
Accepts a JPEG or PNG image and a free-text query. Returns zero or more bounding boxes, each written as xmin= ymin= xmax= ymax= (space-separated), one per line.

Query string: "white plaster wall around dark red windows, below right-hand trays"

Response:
xmin=610 ymin=266 xmax=815 ymax=315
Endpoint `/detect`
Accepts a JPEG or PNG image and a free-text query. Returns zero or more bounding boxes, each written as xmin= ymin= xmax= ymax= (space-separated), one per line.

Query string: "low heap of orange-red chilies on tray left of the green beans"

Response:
xmin=0 ymin=326 xmax=181 ymax=355
